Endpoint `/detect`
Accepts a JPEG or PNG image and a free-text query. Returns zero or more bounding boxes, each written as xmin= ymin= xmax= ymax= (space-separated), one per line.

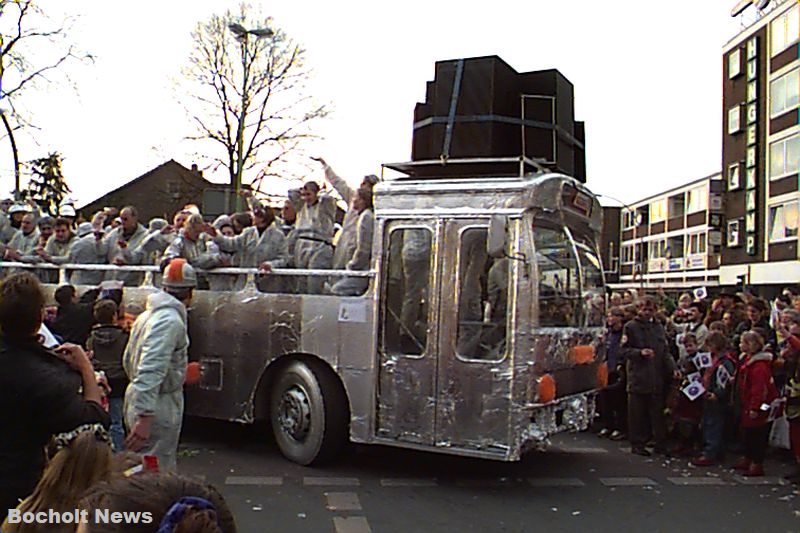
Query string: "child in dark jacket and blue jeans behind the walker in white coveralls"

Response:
xmin=86 ymin=300 xmax=129 ymax=452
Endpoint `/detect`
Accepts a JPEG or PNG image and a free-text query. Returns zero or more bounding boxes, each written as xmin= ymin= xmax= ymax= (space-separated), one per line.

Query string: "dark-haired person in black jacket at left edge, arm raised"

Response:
xmin=0 ymin=273 xmax=109 ymax=519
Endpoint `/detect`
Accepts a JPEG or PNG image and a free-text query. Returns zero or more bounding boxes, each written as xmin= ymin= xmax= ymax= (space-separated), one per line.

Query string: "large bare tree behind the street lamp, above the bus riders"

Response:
xmin=183 ymin=4 xmax=328 ymax=209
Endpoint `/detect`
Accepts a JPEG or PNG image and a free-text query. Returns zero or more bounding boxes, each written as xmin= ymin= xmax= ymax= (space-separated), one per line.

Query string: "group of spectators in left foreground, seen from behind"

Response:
xmin=0 ymin=273 xmax=237 ymax=533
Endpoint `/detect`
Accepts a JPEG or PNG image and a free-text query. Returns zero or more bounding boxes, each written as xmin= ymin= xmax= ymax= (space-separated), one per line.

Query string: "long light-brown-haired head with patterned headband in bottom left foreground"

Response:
xmin=0 ymin=424 xmax=111 ymax=533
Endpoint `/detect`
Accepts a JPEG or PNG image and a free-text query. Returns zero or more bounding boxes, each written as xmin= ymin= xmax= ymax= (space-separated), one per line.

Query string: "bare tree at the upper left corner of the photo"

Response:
xmin=0 ymin=0 xmax=93 ymax=198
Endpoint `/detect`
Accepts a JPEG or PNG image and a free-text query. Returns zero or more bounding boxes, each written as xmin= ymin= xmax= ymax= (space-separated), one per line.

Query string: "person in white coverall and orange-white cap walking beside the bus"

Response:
xmin=123 ymin=258 xmax=197 ymax=470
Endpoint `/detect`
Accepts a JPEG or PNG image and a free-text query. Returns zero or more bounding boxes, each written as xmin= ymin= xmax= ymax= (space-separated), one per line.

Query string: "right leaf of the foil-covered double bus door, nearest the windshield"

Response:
xmin=436 ymin=220 xmax=514 ymax=455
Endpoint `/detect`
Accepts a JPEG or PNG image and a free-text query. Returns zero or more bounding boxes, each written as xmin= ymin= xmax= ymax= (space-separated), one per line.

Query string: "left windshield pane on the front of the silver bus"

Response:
xmin=533 ymin=226 xmax=584 ymax=327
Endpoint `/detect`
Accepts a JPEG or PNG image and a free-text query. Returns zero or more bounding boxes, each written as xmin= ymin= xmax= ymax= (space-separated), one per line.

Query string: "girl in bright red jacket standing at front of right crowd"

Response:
xmin=734 ymin=331 xmax=778 ymax=476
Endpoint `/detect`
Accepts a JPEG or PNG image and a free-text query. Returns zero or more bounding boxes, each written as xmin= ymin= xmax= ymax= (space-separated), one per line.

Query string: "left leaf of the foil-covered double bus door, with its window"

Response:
xmin=376 ymin=220 xmax=440 ymax=444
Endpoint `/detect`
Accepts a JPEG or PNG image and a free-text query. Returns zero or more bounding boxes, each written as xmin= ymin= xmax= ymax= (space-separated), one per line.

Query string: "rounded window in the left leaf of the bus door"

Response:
xmin=383 ymin=224 xmax=432 ymax=355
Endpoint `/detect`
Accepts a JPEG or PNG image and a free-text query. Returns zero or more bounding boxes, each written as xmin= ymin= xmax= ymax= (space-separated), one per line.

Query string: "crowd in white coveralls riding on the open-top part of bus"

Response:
xmin=0 ymin=158 xmax=378 ymax=295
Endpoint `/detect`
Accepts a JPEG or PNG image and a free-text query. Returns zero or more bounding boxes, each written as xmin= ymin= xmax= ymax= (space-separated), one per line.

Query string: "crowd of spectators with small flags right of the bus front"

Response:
xmin=598 ymin=287 xmax=800 ymax=482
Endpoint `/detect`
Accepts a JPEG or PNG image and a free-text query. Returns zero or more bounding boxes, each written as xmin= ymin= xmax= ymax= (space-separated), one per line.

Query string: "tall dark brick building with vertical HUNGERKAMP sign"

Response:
xmin=720 ymin=0 xmax=800 ymax=288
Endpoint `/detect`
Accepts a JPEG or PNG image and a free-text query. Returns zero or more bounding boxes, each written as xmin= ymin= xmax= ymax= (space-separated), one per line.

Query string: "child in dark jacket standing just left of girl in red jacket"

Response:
xmin=692 ymin=330 xmax=736 ymax=466
